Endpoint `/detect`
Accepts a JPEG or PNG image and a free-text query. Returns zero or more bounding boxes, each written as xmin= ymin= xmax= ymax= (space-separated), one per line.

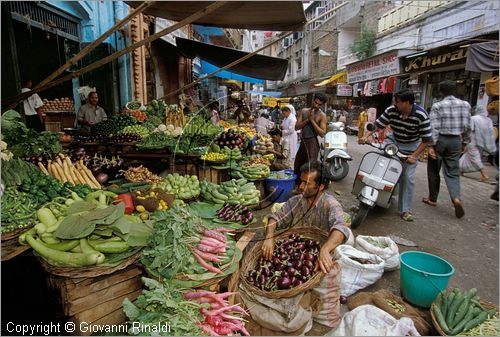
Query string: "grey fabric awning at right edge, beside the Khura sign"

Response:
xmin=465 ymin=41 xmax=498 ymax=73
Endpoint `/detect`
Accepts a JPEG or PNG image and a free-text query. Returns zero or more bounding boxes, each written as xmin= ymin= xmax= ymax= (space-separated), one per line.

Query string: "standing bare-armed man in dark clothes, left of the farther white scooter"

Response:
xmin=294 ymin=93 xmax=327 ymax=176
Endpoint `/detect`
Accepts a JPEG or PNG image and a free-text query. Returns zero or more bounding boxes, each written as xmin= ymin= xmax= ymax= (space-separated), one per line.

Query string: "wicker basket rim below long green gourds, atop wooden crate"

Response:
xmin=38 ymin=250 xmax=142 ymax=278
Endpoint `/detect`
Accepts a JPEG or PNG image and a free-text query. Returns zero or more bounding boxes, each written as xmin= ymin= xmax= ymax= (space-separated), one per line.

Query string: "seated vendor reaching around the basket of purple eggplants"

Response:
xmin=262 ymin=162 xmax=352 ymax=273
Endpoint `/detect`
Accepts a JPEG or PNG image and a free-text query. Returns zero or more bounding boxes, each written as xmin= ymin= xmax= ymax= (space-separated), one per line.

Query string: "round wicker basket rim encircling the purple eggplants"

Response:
xmin=240 ymin=227 xmax=328 ymax=298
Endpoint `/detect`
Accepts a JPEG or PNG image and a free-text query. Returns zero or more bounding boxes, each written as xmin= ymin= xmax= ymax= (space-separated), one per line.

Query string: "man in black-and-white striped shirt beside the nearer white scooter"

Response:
xmin=365 ymin=89 xmax=432 ymax=221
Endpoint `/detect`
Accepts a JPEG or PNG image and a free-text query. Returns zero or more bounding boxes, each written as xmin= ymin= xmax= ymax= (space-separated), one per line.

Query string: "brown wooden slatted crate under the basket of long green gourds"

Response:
xmin=47 ymin=265 xmax=143 ymax=336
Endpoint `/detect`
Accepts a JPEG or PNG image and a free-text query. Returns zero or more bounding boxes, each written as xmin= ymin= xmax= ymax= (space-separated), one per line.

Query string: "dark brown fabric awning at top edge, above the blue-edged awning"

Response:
xmin=126 ymin=1 xmax=307 ymax=31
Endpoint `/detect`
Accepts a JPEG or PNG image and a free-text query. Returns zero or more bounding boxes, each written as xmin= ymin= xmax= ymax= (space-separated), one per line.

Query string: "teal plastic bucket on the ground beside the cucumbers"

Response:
xmin=399 ymin=251 xmax=455 ymax=308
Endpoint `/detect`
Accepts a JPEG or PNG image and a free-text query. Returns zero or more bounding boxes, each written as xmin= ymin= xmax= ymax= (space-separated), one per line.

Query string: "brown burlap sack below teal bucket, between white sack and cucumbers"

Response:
xmin=347 ymin=289 xmax=431 ymax=336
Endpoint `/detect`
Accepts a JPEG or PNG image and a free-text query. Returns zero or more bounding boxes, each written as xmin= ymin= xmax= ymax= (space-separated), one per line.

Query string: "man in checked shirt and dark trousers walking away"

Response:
xmin=422 ymin=81 xmax=471 ymax=218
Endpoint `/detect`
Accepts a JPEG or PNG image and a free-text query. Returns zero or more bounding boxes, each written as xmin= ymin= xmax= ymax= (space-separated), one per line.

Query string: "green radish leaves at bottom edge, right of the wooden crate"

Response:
xmin=123 ymin=277 xmax=204 ymax=336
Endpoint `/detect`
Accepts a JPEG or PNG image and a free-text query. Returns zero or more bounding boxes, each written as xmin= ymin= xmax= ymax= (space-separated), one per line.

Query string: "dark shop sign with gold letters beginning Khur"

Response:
xmin=404 ymin=48 xmax=467 ymax=73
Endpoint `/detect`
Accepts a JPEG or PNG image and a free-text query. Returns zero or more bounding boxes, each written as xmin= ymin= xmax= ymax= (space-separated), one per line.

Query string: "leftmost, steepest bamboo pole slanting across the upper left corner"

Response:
xmin=6 ymin=1 xmax=152 ymax=110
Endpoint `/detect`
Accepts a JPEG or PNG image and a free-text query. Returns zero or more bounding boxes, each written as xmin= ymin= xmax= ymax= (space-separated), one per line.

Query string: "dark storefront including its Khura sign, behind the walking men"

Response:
xmin=402 ymin=45 xmax=481 ymax=109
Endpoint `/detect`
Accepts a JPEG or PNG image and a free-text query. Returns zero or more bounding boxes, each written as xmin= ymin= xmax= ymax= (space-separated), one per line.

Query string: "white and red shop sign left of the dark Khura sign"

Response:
xmin=347 ymin=52 xmax=400 ymax=83
